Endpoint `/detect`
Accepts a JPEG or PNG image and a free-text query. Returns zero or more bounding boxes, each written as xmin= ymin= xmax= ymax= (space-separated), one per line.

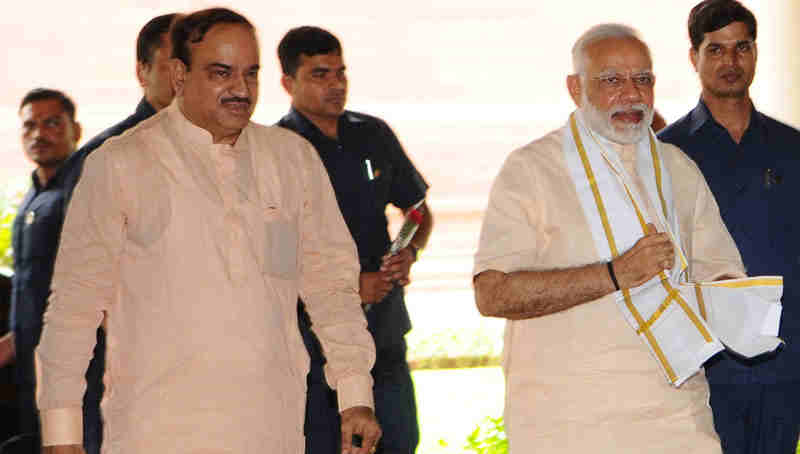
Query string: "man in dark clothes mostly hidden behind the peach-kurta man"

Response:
xmin=57 ymin=14 xmax=176 ymax=454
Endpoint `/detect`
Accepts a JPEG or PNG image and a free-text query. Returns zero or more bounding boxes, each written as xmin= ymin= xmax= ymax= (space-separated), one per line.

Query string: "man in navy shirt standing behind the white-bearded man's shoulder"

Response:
xmin=659 ymin=0 xmax=800 ymax=454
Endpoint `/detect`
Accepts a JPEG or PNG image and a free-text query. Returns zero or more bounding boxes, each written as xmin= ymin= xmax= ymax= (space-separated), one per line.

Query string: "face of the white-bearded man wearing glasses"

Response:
xmin=568 ymin=37 xmax=655 ymax=144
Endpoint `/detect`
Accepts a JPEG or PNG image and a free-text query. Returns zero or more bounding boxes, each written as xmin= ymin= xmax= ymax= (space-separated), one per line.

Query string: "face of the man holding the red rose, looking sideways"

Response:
xmin=281 ymin=52 xmax=347 ymax=127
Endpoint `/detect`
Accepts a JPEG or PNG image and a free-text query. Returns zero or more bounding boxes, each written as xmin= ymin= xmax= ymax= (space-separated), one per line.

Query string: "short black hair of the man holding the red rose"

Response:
xmin=278 ymin=25 xmax=342 ymax=76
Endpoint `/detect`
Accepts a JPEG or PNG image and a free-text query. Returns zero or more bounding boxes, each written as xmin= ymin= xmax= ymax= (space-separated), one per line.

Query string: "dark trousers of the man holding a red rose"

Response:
xmin=298 ymin=303 xmax=419 ymax=454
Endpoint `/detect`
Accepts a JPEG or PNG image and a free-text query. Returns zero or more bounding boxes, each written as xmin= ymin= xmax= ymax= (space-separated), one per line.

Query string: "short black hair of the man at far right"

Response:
xmin=689 ymin=0 xmax=756 ymax=50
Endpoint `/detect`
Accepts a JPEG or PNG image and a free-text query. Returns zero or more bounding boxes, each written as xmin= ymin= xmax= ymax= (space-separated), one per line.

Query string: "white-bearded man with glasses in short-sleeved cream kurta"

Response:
xmin=474 ymin=25 xmax=744 ymax=454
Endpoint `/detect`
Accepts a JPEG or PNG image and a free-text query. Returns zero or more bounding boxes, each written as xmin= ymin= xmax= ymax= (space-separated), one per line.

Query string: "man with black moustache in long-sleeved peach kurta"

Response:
xmin=38 ymin=9 xmax=380 ymax=454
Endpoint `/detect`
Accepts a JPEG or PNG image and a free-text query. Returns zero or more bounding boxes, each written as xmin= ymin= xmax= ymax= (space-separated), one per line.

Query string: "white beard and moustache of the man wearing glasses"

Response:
xmin=579 ymin=90 xmax=654 ymax=145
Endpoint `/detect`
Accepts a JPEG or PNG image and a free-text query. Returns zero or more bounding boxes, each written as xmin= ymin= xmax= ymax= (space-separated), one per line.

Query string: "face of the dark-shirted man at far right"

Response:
xmin=690 ymin=22 xmax=757 ymax=98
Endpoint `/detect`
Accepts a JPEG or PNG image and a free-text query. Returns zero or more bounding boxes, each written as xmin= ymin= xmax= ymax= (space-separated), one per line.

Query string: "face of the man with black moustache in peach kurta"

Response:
xmin=175 ymin=23 xmax=259 ymax=144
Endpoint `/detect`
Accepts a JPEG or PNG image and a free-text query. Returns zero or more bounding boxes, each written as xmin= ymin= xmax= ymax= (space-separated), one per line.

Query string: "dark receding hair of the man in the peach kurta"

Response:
xmin=170 ymin=8 xmax=255 ymax=69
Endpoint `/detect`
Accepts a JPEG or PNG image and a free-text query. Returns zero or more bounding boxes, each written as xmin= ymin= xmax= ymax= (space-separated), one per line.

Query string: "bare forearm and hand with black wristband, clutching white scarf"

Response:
xmin=473 ymin=224 xmax=674 ymax=320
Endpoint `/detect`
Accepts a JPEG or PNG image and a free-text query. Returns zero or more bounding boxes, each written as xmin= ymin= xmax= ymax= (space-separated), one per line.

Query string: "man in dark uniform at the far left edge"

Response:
xmin=0 ymin=88 xmax=81 ymax=450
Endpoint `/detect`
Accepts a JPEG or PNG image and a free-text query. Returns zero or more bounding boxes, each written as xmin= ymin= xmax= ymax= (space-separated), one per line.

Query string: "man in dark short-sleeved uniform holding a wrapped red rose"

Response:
xmin=278 ymin=27 xmax=433 ymax=454
